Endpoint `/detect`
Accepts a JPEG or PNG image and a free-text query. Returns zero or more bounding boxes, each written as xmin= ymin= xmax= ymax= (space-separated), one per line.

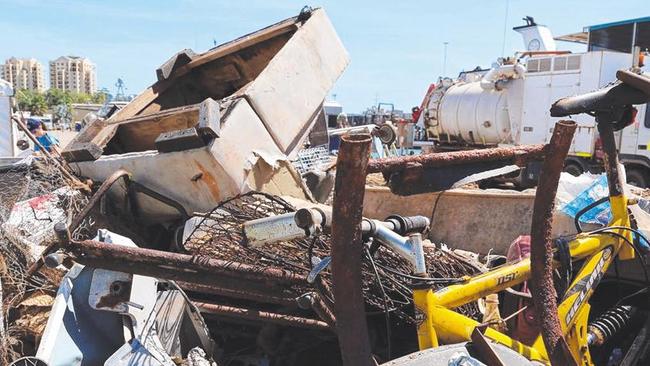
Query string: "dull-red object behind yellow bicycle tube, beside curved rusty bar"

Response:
xmin=506 ymin=235 xmax=541 ymax=345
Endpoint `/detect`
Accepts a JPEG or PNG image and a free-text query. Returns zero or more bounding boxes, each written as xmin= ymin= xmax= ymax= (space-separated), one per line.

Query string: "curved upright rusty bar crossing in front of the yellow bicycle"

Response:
xmin=530 ymin=121 xmax=576 ymax=365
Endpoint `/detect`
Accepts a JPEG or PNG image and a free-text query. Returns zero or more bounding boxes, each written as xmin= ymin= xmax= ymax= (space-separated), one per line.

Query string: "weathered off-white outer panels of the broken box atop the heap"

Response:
xmin=72 ymin=9 xmax=349 ymax=219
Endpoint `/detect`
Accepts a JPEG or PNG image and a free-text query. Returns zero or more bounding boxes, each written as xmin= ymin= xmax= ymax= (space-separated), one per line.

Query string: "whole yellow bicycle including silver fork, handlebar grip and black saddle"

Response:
xmin=296 ymin=71 xmax=650 ymax=365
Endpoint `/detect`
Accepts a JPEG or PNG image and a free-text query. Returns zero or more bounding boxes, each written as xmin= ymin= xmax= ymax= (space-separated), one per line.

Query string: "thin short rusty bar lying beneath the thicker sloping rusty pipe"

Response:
xmin=194 ymin=301 xmax=331 ymax=331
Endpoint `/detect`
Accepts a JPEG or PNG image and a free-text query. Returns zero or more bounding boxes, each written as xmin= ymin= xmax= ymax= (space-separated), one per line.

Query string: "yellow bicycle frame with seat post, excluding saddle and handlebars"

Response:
xmin=413 ymin=121 xmax=634 ymax=365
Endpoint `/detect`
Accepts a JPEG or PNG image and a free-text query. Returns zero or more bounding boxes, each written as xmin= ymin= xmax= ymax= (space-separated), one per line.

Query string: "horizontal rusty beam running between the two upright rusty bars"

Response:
xmin=368 ymin=145 xmax=545 ymax=174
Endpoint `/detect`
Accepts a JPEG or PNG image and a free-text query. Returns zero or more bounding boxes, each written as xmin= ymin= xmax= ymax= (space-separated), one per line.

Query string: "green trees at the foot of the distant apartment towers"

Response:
xmin=16 ymin=89 xmax=107 ymax=115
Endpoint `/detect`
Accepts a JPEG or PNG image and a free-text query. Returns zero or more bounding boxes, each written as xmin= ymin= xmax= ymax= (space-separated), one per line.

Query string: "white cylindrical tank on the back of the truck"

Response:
xmin=436 ymin=81 xmax=511 ymax=145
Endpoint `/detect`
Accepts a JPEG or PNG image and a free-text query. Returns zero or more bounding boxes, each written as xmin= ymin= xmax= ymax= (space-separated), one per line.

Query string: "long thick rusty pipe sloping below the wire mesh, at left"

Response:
xmin=66 ymin=240 xmax=306 ymax=284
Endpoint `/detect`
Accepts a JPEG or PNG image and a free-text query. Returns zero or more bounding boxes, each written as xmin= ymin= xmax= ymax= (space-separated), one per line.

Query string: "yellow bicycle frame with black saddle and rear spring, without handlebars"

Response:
xmin=392 ymin=73 xmax=650 ymax=365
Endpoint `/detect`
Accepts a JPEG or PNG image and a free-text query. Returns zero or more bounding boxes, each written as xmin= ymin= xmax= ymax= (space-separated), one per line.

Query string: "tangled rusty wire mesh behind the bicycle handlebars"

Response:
xmin=184 ymin=192 xmax=479 ymax=323
